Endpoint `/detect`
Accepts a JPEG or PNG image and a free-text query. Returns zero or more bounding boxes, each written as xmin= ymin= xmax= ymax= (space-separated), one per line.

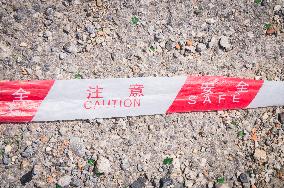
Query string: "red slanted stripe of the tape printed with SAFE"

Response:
xmin=167 ymin=76 xmax=263 ymax=113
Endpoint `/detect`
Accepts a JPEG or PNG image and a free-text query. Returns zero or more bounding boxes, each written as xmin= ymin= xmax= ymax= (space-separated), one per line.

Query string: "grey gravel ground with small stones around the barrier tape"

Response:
xmin=0 ymin=0 xmax=284 ymax=188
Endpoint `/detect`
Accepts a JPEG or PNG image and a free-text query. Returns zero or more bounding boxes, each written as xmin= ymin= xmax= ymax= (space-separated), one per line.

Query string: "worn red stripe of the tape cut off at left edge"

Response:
xmin=0 ymin=80 xmax=54 ymax=122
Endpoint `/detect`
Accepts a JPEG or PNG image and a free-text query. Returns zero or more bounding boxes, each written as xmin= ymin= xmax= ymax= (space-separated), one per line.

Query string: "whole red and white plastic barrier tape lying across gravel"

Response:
xmin=0 ymin=76 xmax=284 ymax=122
